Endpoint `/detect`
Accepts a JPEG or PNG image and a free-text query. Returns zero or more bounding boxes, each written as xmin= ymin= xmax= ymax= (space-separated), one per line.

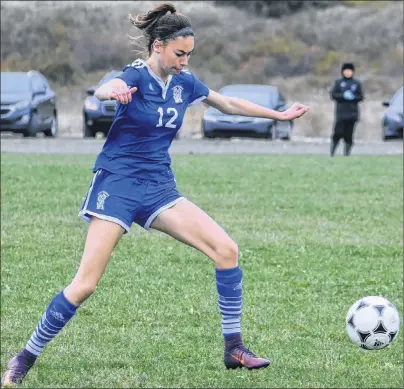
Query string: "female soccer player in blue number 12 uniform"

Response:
xmin=2 ymin=3 xmax=308 ymax=386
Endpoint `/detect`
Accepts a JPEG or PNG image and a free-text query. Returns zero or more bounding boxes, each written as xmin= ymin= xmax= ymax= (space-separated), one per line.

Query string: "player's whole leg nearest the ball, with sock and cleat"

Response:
xmin=151 ymin=200 xmax=270 ymax=369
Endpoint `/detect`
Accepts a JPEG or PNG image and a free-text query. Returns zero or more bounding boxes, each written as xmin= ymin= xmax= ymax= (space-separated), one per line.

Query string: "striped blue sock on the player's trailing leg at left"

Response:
xmin=25 ymin=291 xmax=78 ymax=357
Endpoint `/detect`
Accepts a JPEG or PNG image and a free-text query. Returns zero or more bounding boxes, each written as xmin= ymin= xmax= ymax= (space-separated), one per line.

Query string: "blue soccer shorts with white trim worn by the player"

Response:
xmin=79 ymin=169 xmax=185 ymax=232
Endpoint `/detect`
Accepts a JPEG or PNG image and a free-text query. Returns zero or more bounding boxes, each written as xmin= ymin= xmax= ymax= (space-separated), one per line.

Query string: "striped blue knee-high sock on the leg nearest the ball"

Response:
xmin=216 ymin=266 xmax=243 ymax=340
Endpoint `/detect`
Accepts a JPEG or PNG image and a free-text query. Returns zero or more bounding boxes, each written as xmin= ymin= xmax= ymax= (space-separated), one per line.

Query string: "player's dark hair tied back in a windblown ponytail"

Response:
xmin=129 ymin=3 xmax=194 ymax=56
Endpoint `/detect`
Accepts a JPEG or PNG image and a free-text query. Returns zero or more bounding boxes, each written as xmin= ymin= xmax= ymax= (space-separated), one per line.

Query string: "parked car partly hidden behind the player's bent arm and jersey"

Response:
xmin=83 ymin=70 xmax=122 ymax=138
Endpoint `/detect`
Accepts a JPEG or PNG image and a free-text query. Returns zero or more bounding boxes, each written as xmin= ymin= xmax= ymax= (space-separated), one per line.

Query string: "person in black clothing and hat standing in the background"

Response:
xmin=330 ymin=62 xmax=363 ymax=157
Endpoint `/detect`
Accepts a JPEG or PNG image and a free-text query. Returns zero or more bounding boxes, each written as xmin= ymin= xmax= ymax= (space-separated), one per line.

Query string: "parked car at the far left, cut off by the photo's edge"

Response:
xmin=0 ymin=70 xmax=57 ymax=137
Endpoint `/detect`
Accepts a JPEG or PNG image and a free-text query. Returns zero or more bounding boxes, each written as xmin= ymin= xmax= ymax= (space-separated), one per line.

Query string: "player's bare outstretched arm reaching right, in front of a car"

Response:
xmin=203 ymin=90 xmax=309 ymax=121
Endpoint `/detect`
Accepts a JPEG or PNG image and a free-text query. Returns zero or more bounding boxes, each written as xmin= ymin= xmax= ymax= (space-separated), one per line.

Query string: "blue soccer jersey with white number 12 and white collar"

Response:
xmin=93 ymin=59 xmax=209 ymax=181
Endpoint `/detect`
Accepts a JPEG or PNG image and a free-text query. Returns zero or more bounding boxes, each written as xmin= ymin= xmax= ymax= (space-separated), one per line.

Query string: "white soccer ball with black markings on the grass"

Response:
xmin=346 ymin=296 xmax=400 ymax=350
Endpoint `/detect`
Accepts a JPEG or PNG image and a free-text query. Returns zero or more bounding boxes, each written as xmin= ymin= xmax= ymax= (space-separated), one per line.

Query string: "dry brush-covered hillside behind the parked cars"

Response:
xmin=1 ymin=1 xmax=403 ymax=139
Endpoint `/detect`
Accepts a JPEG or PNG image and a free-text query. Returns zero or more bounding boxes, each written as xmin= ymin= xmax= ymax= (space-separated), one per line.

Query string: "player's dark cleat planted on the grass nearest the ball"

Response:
xmin=224 ymin=336 xmax=271 ymax=370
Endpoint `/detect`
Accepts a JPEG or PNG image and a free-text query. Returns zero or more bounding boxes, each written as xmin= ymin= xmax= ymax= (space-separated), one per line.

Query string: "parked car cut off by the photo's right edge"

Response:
xmin=382 ymin=87 xmax=403 ymax=140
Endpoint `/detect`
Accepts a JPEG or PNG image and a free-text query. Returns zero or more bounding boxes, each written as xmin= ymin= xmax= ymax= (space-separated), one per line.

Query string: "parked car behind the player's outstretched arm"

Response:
xmin=202 ymin=84 xmax=293 ymax=140
